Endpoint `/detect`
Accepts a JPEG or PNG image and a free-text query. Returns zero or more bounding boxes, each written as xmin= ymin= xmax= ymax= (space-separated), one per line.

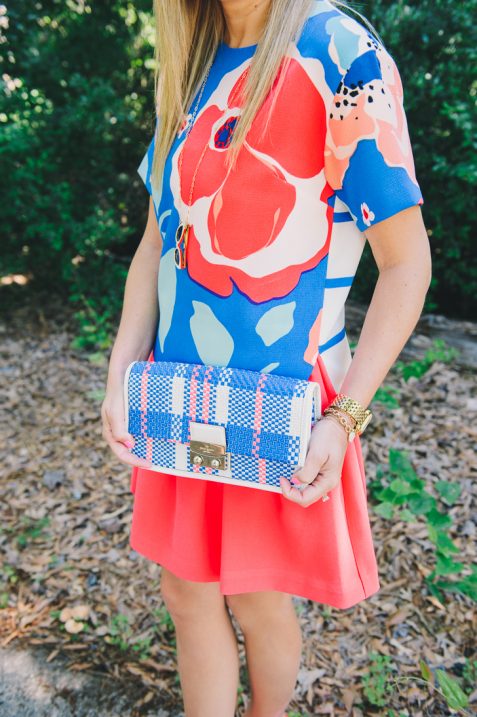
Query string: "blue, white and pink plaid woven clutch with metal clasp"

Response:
xmin=124 ymin=361 xmax=321 ymax=493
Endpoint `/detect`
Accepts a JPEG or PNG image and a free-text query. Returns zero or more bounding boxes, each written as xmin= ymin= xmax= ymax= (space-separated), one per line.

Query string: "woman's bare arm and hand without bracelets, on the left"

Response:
xmin=101 ymin=198 xmax=162 ymax=467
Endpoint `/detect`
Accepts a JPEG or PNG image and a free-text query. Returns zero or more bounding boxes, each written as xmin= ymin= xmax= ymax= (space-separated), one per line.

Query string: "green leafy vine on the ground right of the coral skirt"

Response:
xmin=370 ymin=448 xmax=477 ymax=601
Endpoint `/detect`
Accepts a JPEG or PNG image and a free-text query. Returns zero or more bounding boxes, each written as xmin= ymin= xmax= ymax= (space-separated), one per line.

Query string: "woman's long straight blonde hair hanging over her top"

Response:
xmin=151 ymin=0 xmax=380 ymax=192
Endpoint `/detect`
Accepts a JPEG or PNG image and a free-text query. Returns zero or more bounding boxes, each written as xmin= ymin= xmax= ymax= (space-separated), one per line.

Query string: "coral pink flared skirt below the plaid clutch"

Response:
xmin=130 ymin=355 xmax=380 ymax=609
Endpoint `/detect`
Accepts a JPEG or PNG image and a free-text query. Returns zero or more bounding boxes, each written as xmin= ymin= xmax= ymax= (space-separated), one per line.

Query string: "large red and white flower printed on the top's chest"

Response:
xmin=174 ymin=59 xmax=332 ymax=302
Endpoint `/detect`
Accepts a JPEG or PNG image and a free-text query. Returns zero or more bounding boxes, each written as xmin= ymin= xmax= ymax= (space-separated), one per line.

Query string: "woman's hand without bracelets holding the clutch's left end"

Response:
xmin=101 ymin=383 xmax=152 ymax=468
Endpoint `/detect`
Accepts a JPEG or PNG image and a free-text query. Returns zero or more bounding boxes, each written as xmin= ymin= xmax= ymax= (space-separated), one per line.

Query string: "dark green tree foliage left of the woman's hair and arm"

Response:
xmin=0 ymin=0 xmax=154 ymax=349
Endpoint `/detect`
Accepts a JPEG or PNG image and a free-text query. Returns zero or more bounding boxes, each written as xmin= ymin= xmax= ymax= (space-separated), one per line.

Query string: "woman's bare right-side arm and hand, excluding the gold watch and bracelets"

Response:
xmin=281 ymin=205 xmax=432 ymax=507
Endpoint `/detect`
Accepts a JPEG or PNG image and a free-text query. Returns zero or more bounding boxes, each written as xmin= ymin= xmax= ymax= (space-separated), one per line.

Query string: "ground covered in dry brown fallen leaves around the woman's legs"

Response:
xmin=0 ymin=292 xmax=477 ymax=717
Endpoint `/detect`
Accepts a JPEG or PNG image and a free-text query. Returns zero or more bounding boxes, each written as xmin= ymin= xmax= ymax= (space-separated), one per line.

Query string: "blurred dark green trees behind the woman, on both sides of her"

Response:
xmin=0 ymin=0 xmax=477 ymax=349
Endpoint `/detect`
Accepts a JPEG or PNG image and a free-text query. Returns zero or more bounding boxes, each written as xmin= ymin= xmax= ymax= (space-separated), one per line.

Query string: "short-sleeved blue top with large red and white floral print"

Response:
xmin=138 ymin=0 xmax=423 ymax=391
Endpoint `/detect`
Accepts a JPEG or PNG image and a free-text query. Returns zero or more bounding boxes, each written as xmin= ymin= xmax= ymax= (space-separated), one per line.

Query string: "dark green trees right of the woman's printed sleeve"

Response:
xmin=350 ymin=0 xmax=477 ymax=319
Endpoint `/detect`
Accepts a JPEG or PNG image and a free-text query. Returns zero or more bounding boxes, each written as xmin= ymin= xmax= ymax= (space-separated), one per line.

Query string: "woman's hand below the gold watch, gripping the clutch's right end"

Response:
xmin=280 ymin=416 xmax=349 ymax=508
